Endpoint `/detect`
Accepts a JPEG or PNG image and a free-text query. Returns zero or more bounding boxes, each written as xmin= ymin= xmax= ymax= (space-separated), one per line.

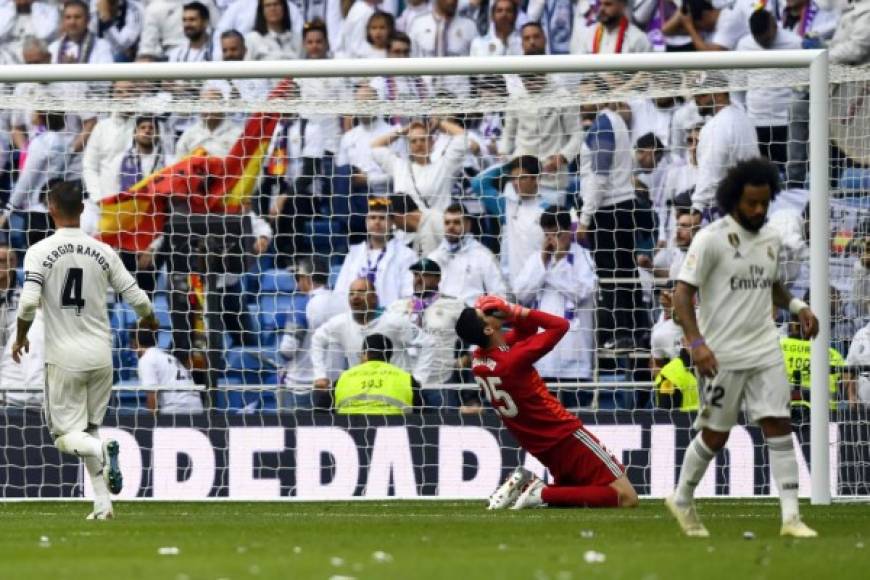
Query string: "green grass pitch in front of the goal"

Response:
xmin=0 ymin=501 xmax=870 ymax=580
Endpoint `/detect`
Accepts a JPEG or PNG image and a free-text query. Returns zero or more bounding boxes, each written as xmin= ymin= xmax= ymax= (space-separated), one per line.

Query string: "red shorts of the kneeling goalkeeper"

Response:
xmin=538 ymin=427 xmax=625 ymax=486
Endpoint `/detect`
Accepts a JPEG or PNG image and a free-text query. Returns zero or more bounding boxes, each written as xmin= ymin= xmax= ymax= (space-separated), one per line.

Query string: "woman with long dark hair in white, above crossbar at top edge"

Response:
xmin=245 ymin=0 xmax=302 ymax=60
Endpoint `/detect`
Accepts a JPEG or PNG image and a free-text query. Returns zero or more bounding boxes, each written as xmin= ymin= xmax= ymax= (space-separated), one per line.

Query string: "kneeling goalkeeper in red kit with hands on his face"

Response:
xmin=456 ymin=296 xmax=637 ymax=509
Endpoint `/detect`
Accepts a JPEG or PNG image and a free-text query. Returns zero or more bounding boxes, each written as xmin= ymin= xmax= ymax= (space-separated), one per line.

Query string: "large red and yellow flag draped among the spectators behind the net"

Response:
xmin=99 ymin=79 xmax=292 ymax=252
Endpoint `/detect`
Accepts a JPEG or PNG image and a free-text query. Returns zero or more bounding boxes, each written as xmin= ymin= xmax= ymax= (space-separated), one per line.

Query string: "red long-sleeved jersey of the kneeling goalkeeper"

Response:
xmin=471 ymin=310 xmax=583 ymax=454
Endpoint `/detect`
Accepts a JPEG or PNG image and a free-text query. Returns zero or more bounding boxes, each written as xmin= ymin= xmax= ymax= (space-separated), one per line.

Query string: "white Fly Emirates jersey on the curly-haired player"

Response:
xmin=678 ymin=216 xmax=782 ymax=370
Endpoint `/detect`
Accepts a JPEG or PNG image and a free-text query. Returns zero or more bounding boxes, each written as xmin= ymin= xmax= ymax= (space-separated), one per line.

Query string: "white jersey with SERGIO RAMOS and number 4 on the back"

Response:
xmin=19 ymin=228 xmax=151 ymax=371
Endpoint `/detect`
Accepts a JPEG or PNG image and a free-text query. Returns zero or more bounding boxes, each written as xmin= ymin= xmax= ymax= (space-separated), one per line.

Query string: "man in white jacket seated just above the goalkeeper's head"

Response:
xmin=429 ymin=203 xmax=507 ymax=306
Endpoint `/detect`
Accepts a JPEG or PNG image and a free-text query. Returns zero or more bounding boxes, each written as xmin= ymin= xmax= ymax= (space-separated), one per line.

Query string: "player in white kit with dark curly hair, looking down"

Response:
xmin=665 ymin=157 xmax=819 ymax=538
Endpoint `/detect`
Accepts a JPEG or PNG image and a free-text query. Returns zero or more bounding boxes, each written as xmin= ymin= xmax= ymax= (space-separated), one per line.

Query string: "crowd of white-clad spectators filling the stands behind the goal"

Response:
xmin=0 ymin=0 xmax=870 ymax=412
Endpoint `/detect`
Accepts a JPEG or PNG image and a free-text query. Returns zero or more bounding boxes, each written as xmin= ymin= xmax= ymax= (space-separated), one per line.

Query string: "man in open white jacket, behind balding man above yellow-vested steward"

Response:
xmin=334 ymin=198 xmax=417 ymax=308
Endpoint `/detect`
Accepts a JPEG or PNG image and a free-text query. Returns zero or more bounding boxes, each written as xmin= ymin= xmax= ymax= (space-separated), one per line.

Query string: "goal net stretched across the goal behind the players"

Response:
xmin=0 ymin=55 xmax=870 ymax=499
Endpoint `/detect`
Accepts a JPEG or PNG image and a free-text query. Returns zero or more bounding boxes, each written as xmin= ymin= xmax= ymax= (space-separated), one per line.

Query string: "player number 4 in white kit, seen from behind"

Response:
xmin=12 ymin=182 xmax=157 ymax=520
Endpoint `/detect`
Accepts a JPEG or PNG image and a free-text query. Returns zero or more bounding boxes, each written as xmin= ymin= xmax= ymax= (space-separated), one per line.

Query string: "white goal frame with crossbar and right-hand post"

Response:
xmin=0 ymin=50 xmax=844 ymax=504
